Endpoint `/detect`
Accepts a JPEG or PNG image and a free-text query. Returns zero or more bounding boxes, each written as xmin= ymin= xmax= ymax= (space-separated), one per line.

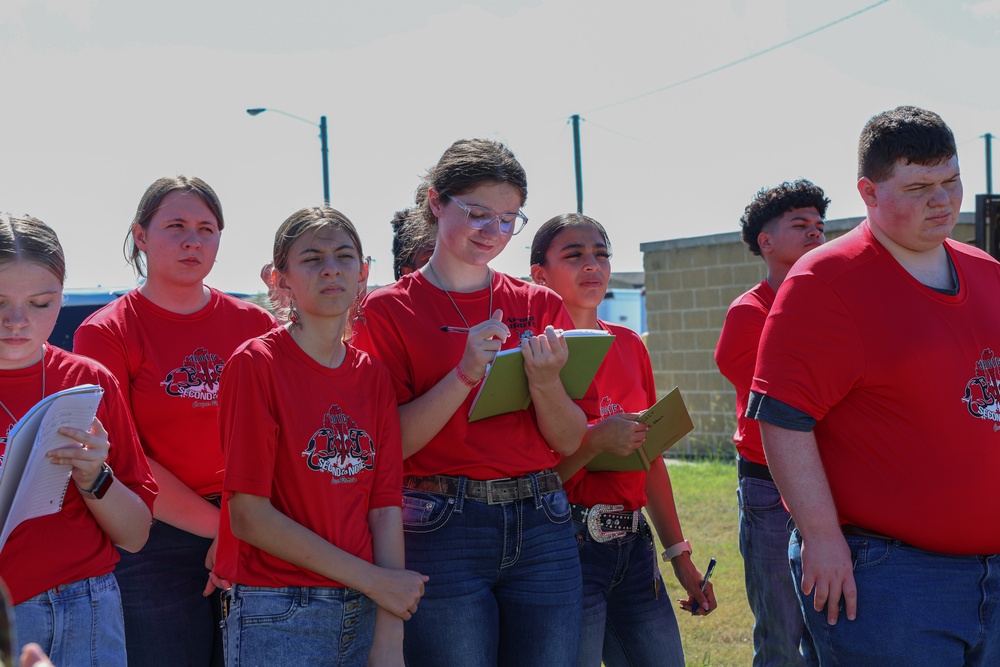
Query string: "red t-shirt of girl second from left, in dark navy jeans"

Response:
xmin=73 ymin=289 xmax=275 ymax=496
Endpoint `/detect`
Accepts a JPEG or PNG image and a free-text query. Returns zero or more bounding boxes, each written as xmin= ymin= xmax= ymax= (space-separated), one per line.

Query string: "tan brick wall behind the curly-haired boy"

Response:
xmin=640 ymin=213 xmax=974 ymax=456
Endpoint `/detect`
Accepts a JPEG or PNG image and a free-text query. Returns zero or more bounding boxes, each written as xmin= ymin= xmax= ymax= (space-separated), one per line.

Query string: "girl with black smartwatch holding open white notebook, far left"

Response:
xmin=0 ymin=215 xmax=156 ymax=665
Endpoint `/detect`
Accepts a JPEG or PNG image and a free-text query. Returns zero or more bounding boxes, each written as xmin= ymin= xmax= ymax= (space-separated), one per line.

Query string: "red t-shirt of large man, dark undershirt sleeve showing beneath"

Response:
xmin=752 ymin=223 xmax=1000 ymax=554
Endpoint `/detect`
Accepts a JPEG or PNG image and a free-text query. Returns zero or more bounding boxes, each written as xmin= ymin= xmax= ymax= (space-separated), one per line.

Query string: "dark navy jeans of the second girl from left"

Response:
xmin=115 ymin=521 xmax=223 ymax=667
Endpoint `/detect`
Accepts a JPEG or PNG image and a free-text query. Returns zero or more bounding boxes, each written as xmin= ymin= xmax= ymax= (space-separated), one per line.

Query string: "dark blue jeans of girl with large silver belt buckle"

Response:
xmin=573 ymin=517 xmax=684 ymax=667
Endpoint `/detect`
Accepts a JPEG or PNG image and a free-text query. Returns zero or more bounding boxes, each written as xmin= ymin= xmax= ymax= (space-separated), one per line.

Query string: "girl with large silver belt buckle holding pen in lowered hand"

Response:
xmin=531 ymin=213 xmax=716 ymax=667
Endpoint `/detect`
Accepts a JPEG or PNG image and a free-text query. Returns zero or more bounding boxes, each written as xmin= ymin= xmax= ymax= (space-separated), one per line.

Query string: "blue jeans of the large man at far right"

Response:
xmin=788 ymin=530 xmax=1000 ymax=667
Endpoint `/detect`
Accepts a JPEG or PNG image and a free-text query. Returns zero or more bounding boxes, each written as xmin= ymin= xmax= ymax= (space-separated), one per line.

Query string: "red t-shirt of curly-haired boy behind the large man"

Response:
xmin=715 ymin=280 xmax=774 ymax=465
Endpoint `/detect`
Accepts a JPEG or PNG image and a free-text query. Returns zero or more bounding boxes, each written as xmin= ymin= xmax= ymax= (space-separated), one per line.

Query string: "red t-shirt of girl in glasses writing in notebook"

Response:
xmin=353 ymin=272 xmax=574 ymax=479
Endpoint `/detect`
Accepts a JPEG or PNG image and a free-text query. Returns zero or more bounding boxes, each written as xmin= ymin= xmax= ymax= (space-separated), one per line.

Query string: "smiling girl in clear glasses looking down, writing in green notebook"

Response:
xmin=355 ymin=139 xmax=586 ymax=667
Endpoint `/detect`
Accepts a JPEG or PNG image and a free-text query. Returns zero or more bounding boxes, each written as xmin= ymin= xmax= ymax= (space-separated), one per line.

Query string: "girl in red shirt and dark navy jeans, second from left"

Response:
xmin=73 ymin=176 xmax=274 ymax=667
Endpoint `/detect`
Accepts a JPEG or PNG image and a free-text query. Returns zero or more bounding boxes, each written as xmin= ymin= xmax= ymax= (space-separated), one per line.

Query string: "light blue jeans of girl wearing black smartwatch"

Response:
xmin=13 ymin=574 xmax=126 ymax=667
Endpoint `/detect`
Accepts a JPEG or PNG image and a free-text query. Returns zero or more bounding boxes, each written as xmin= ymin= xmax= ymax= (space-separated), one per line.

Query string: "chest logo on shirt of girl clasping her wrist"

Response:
xmin=302 ymin=405 xmax=375 ymax=484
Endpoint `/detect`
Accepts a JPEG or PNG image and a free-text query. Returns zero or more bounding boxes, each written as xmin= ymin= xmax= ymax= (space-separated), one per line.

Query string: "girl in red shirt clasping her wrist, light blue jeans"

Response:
xmin=220 ymin=207 xmax=426 ymax=665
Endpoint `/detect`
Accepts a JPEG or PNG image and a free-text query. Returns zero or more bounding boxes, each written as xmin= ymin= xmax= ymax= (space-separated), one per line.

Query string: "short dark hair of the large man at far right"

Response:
xmin=858 ymin=106 xmax=958 ymax=183
